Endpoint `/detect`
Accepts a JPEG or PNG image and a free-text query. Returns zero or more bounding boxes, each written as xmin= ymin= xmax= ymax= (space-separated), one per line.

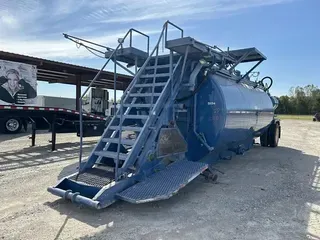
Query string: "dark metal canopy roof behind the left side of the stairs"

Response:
xmin=0 ymin=51 xmax=133 ymax=91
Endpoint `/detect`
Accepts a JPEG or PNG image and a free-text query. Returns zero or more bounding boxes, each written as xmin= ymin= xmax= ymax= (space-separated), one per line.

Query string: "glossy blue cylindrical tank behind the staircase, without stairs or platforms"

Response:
xmin=178 ymin=70 xmax=279 ymax=161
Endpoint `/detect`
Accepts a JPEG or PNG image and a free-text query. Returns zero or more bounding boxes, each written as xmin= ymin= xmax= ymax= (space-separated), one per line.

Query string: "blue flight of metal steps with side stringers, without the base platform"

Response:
xmin=79 ymin=23 xmax=185 ymax=181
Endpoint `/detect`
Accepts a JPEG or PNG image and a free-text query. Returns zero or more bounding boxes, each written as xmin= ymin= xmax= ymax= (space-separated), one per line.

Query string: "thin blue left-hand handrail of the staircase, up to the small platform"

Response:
xmin=74 ymin=28 xmax=149 ymax=178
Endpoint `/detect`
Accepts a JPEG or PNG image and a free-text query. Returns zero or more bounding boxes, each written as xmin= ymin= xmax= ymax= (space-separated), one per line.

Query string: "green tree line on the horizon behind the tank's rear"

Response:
xmin=276 ymin=84 xmax=320 ymax=115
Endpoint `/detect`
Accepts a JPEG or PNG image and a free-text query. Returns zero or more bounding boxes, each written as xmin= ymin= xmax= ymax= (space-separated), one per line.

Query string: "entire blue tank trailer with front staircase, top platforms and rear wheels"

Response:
xmin=48 ymin=21 xmax=281 ymax=209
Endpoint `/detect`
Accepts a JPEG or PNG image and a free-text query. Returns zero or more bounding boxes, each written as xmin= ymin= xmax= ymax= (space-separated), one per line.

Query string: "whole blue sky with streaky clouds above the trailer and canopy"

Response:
xmin=0 ymin=0 xmax=320 ymax=98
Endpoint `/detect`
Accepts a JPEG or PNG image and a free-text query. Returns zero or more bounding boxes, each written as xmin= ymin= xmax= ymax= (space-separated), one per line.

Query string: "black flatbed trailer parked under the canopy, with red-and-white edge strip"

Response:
xmin=0 ymin=105 xmax=107 ymax=150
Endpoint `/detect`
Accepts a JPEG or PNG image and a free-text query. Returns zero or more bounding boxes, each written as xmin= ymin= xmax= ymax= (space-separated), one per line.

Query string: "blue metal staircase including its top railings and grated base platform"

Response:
xmin=48 ymin=21 xmax=214 ymax=208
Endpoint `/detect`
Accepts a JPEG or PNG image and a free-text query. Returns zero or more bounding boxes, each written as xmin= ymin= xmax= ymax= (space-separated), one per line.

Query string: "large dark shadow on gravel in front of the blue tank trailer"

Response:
xmin=45 ymin=146 xmax=320 ymax=240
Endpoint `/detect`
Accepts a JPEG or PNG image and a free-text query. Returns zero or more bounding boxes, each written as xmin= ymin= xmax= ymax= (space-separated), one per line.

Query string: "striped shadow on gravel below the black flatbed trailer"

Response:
xmin=0 ymin=140 xmax=96 ymax=172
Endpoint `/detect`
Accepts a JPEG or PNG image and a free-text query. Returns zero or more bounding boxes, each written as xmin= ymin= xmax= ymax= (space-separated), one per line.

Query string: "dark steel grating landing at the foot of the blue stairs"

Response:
xmin=69 ymin=168 xmax=114 ymax=188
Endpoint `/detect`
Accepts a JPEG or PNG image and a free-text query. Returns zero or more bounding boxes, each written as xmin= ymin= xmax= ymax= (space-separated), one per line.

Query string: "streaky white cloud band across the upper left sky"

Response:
xmin=0 ymin=0 xmax=291 ymax=59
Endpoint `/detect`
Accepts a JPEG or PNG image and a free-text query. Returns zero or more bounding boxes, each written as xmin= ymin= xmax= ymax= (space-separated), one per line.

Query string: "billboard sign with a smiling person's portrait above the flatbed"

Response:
xmin=0 ymin=60 xmax=37 ymax=105
